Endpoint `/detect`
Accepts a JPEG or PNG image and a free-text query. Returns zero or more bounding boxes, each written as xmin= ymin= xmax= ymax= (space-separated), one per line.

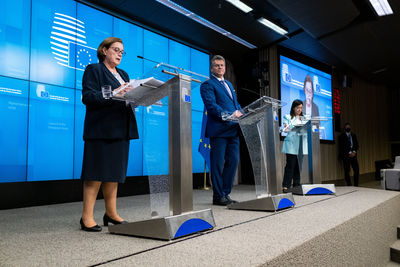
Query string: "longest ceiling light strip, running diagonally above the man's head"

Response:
xmin=156 ymin=0 xmax=257 ymax=49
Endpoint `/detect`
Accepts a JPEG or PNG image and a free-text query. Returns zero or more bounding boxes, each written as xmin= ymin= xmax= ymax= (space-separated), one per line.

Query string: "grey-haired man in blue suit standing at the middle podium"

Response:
xmin=200 ymin=55 xmax=243 ymax=206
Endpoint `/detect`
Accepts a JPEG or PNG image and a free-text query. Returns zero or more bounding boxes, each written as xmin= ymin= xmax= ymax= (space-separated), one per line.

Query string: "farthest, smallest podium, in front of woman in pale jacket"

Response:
xmin=289 ymin=118 xmax=336 ymax=195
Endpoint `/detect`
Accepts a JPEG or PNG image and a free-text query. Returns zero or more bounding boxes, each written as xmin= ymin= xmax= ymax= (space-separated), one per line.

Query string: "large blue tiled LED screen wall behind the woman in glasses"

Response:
xmin=0 ymin=0 xmax=209 ymax=183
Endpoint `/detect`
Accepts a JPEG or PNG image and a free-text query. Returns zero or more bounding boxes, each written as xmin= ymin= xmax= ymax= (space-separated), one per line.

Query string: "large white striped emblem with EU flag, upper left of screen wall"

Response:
xmin=50 ymin=13 xmax=97 ymax=71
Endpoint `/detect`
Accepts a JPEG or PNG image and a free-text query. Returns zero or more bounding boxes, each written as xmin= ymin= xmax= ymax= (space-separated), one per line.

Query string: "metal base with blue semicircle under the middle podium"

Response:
xmin=228 ymin=193 xmax=295 ymax=211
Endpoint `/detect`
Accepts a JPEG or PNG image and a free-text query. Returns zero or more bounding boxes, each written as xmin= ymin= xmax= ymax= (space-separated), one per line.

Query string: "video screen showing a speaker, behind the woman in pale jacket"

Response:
xmin=280 ymin=55 xmax=334 ymax=141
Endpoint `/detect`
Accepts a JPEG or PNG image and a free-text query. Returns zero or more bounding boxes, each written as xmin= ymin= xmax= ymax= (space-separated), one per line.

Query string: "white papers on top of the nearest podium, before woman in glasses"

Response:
xmin=124 ymin=77 xmax=168 ymax=106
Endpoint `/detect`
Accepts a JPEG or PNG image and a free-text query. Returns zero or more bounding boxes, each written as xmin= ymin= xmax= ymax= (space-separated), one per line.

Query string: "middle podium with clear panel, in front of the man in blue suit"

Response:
xmin=228 ymin=96 xmax=295 ymax=211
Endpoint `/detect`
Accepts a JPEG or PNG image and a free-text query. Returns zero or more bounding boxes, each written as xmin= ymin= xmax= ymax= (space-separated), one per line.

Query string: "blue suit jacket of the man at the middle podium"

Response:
xmin=200 ymin=75 xmax=242 ymax=137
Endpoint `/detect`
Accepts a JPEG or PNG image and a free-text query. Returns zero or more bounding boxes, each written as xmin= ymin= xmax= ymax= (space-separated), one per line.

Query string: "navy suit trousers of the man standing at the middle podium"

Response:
xmin=210 ymin=137 xmax=239 ymax=200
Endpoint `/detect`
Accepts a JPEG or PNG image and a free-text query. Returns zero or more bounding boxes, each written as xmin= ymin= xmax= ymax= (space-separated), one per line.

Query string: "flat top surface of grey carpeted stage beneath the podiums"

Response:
xmin=0 ymin=185 xmax=400 ymax=266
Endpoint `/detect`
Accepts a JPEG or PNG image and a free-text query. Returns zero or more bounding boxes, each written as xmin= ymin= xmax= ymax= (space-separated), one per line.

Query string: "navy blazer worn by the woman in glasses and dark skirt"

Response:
xmin=82 ymin=63 xmax=139 ymax=140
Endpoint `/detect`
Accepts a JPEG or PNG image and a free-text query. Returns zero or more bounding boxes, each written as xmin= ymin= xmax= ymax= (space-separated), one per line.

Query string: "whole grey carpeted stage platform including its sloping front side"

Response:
xmin=0 ymin=185 xmax=400 ymax=266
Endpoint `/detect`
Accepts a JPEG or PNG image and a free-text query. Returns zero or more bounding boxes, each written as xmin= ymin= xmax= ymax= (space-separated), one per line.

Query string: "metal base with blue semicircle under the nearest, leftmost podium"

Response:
xmin=108 ymin=209 xmax=215 ymax=240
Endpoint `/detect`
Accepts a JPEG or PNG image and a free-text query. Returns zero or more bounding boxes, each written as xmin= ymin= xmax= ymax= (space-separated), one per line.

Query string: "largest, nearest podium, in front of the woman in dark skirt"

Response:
xmin=108 ymin=64 xmax=215 ymax=240
